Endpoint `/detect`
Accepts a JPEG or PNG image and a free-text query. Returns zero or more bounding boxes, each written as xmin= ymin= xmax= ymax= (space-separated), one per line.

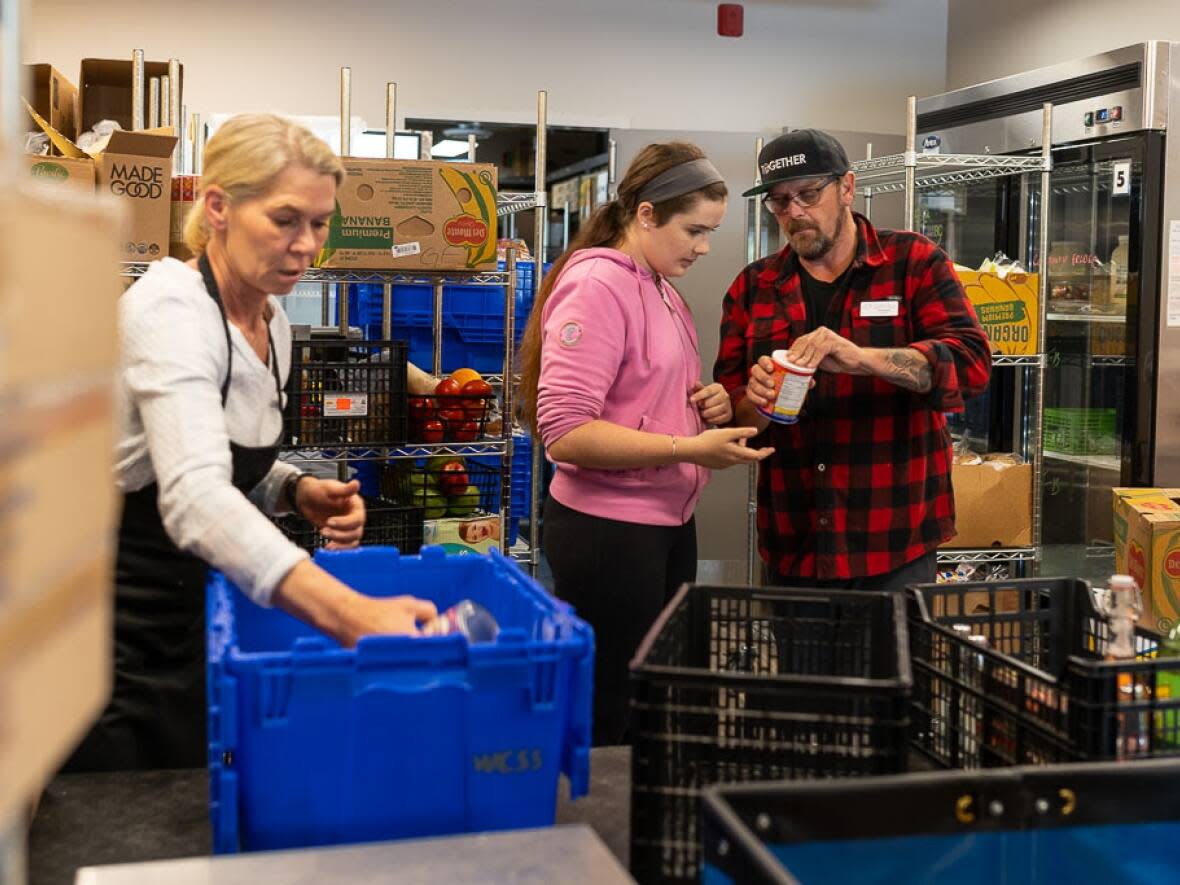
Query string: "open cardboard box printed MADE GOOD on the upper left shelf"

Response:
xmin=96 ymin=132 xmax=176 ymax=261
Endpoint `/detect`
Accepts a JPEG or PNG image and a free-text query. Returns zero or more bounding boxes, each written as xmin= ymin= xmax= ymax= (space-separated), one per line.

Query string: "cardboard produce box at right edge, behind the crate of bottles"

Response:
xmin=1112 ymin=489 xmax=1180 ymax=634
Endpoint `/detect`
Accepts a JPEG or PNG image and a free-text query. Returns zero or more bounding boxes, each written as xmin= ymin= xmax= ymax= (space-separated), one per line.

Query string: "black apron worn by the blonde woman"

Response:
xmin=66 ymin=255 xmax=282 ymax=771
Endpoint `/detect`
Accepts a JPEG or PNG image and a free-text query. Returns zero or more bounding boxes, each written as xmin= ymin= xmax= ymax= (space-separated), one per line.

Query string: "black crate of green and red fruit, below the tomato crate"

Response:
xmin=381 ymin=455 xmax=503 ymax=519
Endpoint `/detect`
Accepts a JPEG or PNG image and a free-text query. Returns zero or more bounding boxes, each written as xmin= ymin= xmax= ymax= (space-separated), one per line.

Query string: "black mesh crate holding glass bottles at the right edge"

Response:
xmin=909 ymin=578 xmax=1180 ymax=768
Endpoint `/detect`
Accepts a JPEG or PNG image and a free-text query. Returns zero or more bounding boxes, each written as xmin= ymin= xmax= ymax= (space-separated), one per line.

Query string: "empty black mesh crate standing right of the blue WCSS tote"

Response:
xmin=630 ymin=584 xmax=911 ymax=883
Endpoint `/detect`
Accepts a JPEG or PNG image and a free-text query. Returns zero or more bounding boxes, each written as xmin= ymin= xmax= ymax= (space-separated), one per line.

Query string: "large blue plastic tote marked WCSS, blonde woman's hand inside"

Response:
xmin=207 ymin=548 xmax=594 ymax=853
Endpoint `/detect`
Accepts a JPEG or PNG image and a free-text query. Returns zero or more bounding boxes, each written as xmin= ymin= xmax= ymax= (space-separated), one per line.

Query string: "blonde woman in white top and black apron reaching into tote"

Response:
xmin=68 ymin=114 xmax=434 ymax=769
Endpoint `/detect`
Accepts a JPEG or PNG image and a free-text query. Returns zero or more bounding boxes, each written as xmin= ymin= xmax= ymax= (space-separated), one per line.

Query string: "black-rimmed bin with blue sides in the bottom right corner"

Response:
xmin=701 ymin=760 xmax=1180 ymax=885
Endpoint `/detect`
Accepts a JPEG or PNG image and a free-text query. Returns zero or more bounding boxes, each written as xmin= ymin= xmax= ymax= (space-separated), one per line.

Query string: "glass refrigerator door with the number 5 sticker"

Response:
xmin=1027 ymin=133 xmax=1162 ymax=577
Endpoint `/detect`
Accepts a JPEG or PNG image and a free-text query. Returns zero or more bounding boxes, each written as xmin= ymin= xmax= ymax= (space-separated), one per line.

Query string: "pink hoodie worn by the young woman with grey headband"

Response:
xmin=537 ymin=249 xmax=709 ymax=525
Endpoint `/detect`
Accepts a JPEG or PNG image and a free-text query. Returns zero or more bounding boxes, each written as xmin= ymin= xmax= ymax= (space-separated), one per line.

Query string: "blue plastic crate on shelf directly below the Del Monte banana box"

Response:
xmin=339 ymin=261 xmax=550 ymax=373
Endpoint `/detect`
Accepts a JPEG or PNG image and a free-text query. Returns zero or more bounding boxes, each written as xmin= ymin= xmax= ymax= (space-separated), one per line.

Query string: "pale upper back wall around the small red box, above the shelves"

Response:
xmin=25 ymin=0 xmax=946 ymax=132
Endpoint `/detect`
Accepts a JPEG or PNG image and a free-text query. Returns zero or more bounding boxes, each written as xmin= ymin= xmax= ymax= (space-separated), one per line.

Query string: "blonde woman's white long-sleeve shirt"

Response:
xmin=116 ymin=258 xmax=308 ymax=605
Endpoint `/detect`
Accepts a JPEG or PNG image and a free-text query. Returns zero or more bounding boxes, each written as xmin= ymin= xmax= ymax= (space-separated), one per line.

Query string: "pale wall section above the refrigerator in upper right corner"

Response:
xmin=946 ymin=0 xmax=1180 ymax=90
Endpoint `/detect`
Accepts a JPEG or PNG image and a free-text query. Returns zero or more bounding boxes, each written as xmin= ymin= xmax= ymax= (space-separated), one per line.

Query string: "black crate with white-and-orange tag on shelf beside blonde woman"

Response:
xmin=283 ymin=339 xmax=406 ymax=448
